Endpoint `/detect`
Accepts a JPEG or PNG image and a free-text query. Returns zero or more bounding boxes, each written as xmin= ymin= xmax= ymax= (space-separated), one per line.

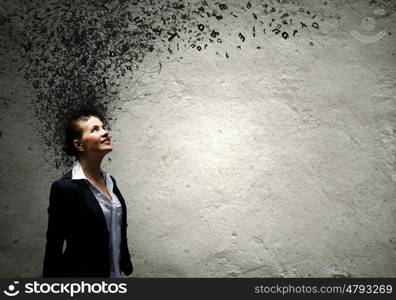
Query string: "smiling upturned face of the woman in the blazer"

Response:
xmin=74 ymin=117 xmax=113 ymax=155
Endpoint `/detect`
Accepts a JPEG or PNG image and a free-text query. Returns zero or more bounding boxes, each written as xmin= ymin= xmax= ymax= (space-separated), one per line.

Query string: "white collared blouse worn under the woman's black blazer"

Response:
xmin=72 ymin=161 xmax=122 ymax=278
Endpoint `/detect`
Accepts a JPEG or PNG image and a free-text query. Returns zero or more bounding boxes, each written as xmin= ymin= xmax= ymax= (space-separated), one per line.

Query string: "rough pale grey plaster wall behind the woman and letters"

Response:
xmin=0 ymin=0 xmax=396 ymax=277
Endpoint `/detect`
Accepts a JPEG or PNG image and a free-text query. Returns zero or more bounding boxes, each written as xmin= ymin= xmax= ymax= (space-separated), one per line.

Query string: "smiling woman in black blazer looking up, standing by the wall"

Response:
xmin=43 ymin=114 xmax=133 ymax=277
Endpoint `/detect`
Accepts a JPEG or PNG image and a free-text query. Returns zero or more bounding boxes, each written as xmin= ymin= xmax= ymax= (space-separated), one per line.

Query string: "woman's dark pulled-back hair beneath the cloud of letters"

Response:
xmin=63 ymin=113 xmax=103 ymax=157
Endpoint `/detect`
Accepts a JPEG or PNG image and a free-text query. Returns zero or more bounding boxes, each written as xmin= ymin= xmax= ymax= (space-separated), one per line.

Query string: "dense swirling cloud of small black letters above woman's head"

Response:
xmin=13 ymin=0 xmax=326 ymax=166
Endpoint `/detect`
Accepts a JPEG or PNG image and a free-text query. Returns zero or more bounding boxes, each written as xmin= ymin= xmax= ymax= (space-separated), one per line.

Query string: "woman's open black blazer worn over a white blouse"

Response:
xmin=43 ymin=171 xmax=133 ymax=277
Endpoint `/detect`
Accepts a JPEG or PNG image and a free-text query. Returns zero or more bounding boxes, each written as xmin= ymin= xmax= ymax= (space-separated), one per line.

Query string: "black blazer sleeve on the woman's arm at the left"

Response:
xmin=43 ymin=181 xmax=66 ymax=277
